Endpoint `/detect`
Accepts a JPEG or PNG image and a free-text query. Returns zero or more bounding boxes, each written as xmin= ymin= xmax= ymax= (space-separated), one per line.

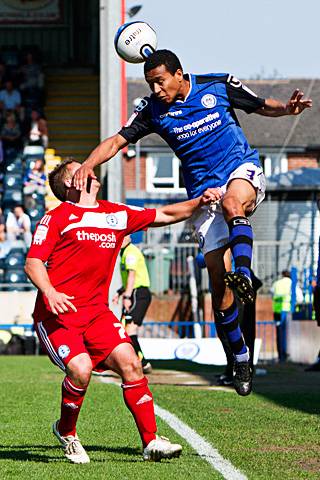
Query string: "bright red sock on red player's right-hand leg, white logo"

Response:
xmin=121 ymin=377 xmax=157 ymax=447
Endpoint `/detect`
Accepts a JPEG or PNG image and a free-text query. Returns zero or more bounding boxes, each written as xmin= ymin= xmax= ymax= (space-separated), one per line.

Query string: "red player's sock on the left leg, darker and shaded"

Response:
xmin=58 ymin=377 xmax=87 ymax=437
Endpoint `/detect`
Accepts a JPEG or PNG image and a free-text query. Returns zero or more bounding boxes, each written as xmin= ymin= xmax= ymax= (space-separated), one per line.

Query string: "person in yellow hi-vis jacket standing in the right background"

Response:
xmin=271 ymin=270 xmax=303 ymax=362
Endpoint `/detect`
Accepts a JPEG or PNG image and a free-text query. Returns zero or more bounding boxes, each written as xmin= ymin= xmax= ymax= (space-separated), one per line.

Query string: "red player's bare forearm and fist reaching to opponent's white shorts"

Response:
xmin=150 ymin=188 xmax=222 ymax=227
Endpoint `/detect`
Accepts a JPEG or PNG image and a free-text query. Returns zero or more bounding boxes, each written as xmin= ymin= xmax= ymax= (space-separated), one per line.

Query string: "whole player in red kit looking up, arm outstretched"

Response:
xmin=25 ymin=158 xmax=219 ymax=463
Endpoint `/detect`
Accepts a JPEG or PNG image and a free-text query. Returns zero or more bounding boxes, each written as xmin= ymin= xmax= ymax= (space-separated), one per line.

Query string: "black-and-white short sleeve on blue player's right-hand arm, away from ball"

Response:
xmin=226 ymin=75 xmax=265 ymax=113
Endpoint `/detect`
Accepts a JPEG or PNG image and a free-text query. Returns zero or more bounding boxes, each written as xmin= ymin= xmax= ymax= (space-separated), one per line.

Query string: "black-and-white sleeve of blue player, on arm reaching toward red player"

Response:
xmin=118 ymin=97 xmax=154 ymax=143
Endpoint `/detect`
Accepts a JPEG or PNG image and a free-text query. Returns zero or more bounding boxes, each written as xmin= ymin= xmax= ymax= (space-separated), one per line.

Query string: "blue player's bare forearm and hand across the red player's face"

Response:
xmin=73 ymin=133 xmax=128 ymax=190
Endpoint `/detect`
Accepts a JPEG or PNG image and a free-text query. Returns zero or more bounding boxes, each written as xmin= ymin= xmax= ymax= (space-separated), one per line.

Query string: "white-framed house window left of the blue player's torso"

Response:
xmin=146 ymin=153 xmax=185 ymax=193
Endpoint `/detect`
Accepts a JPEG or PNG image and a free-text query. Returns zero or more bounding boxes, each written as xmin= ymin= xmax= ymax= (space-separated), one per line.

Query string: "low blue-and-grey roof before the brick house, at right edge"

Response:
xmin=267 ymin=167 xmax=320 ymax=191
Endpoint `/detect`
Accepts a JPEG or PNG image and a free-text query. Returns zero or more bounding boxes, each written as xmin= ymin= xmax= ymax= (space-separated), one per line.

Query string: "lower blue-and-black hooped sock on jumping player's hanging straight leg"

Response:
xmin=214 ymin=301 xmax=249 ymax=355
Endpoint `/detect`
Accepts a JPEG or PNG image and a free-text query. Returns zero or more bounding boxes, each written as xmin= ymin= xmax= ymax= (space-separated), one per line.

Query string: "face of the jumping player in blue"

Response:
xmin=146 ymin=65 xmax=183 ymax=103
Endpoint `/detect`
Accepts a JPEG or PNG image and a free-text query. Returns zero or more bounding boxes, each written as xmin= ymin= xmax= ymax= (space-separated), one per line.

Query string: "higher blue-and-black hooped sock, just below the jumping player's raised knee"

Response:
xmin=228 ymin=217 xmax=253 ymax=278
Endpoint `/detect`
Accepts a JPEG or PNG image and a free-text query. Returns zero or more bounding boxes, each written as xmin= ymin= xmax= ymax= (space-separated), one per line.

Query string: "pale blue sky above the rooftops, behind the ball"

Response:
xmin=127 ymin=0 xmax=320 ymax=79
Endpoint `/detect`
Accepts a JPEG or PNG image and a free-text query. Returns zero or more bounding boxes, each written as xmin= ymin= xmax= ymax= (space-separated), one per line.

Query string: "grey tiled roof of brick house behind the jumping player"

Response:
xmin=128 ymin=78 xmax=320 ymax=151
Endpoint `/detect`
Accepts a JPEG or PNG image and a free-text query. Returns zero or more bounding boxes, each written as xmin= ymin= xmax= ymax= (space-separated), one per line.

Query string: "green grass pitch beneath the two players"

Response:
xmin=0 ymin=356 xmax=320 ymax=480
